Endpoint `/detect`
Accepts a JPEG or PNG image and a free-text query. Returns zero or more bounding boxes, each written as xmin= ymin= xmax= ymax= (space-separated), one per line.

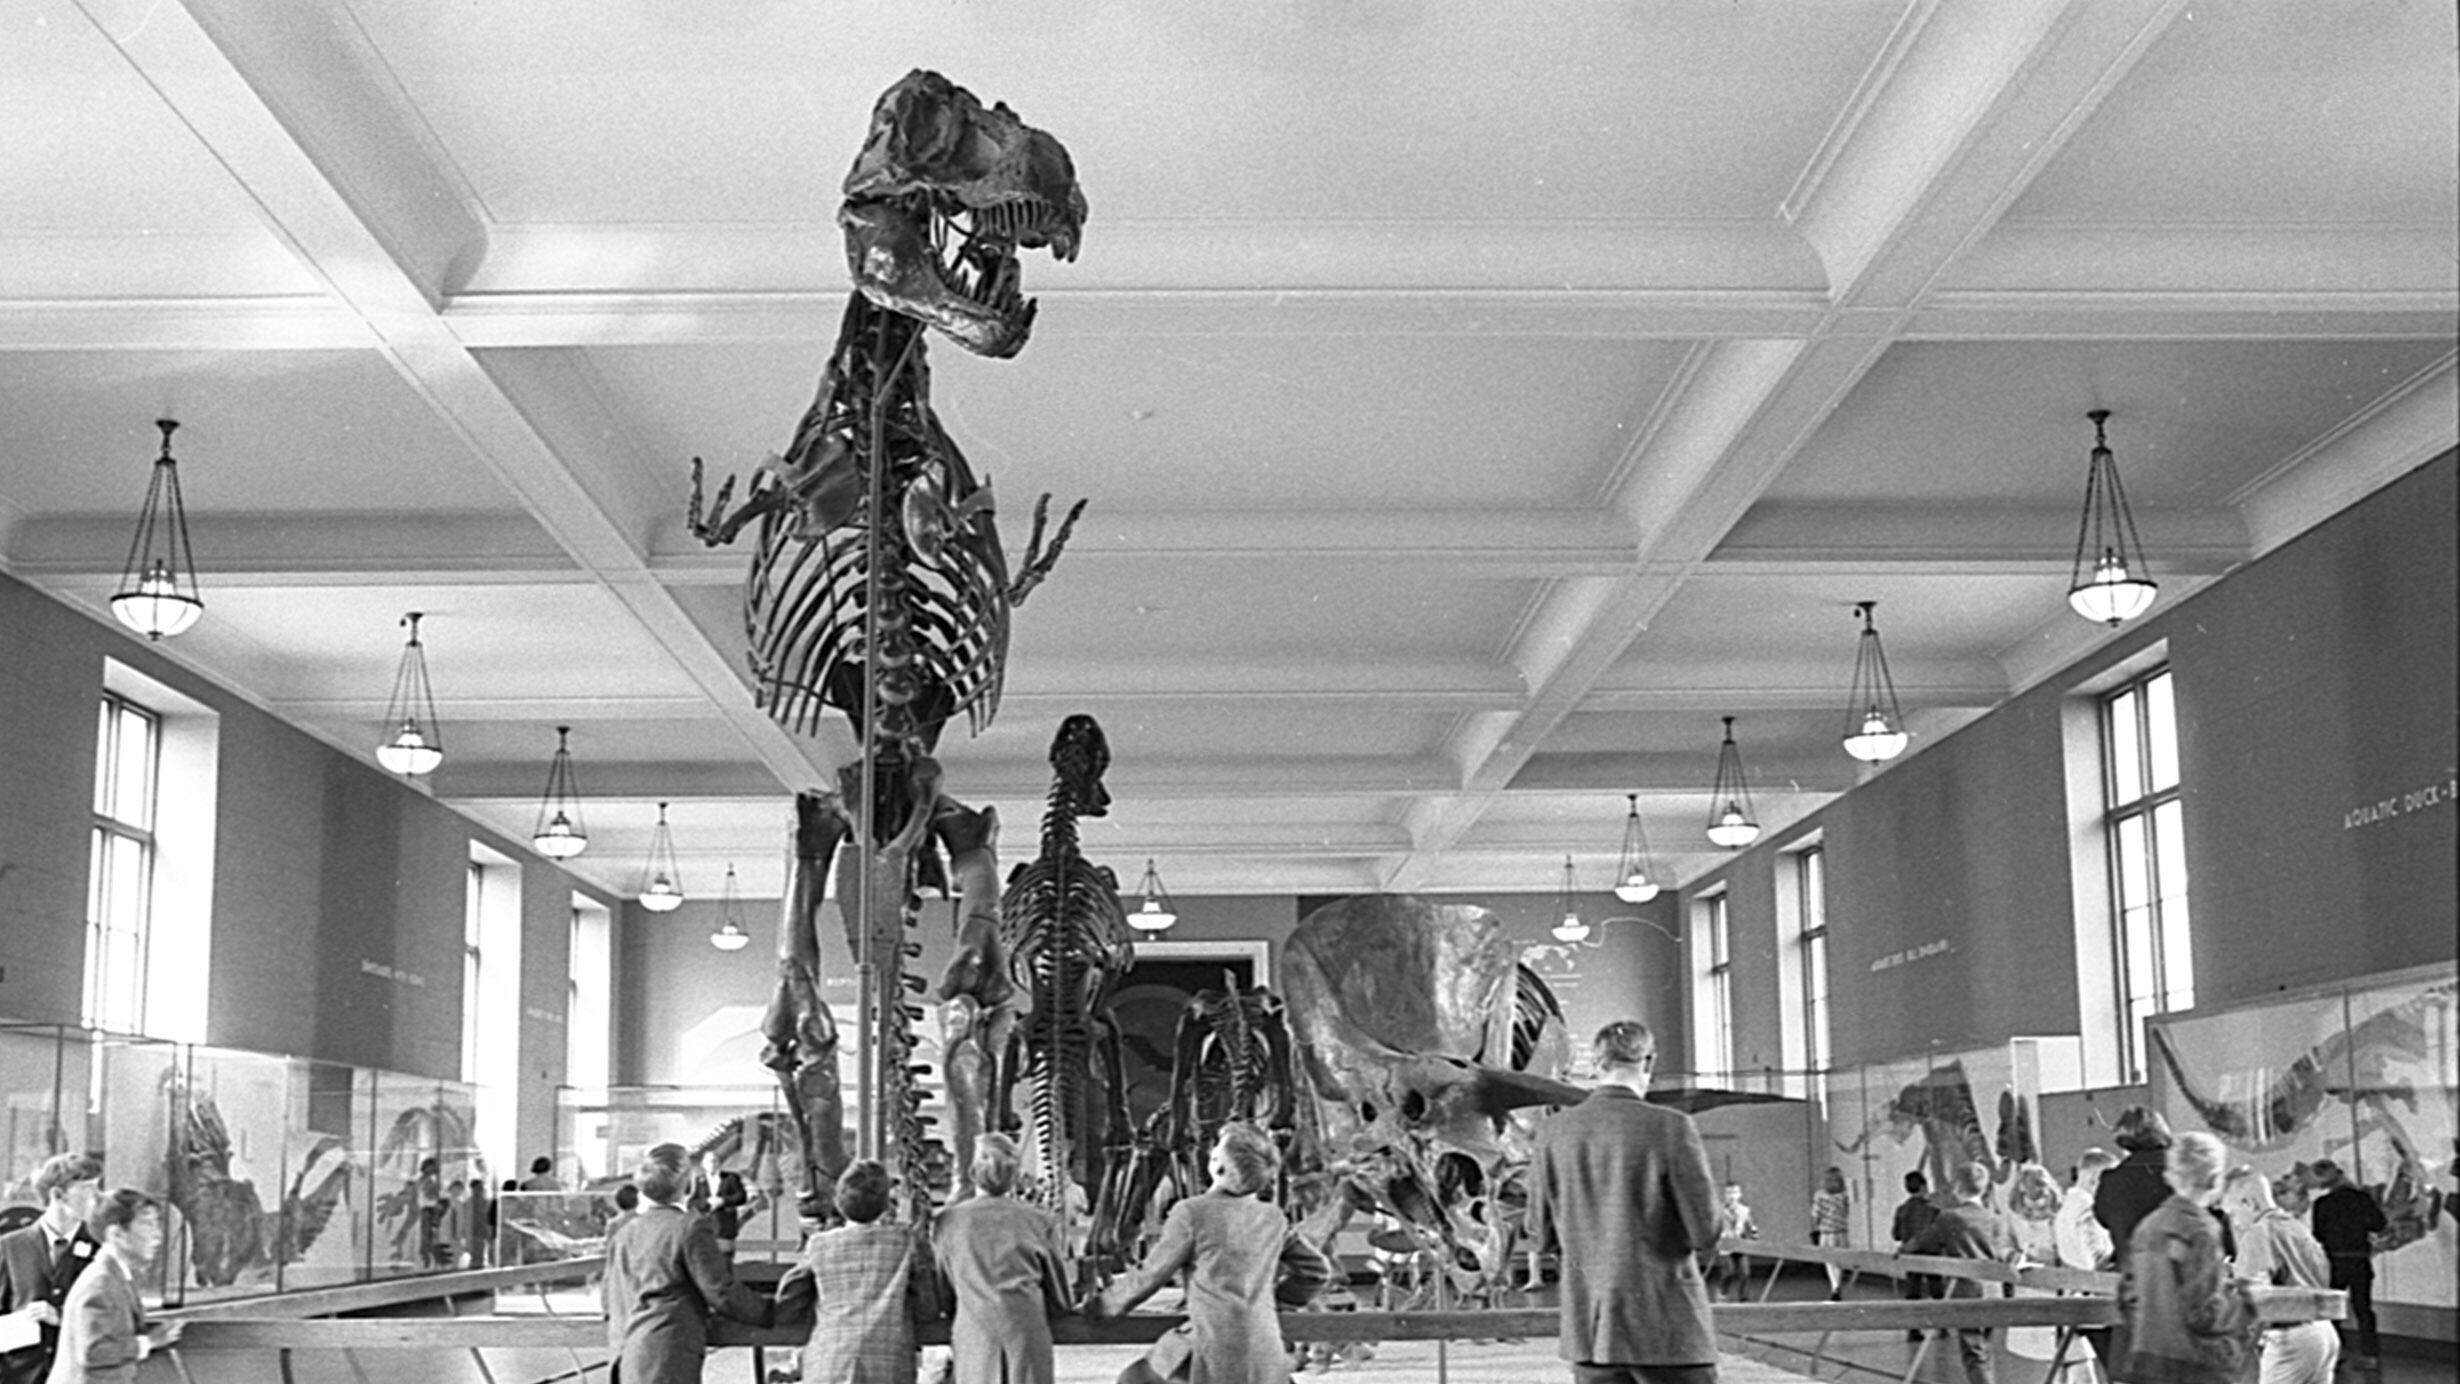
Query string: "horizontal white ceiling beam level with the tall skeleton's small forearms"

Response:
xmin=7 ymin=499 xmax=2253 ymax=588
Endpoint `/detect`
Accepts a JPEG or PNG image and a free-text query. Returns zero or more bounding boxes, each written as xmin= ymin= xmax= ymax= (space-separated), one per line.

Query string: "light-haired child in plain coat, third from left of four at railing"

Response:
xmin=932 ymin=1133 xmax=1075 ymax=1384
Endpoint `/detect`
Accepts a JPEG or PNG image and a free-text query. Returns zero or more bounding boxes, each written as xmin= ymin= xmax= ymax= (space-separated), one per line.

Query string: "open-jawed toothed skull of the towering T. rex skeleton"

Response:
xmin=836 ymin=69 xmax=1085 ymax=356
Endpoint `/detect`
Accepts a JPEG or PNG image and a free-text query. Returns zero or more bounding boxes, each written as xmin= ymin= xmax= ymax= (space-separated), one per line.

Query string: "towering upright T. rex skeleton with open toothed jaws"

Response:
xmin=689 ymin=71 xmax=1085 ymax=1224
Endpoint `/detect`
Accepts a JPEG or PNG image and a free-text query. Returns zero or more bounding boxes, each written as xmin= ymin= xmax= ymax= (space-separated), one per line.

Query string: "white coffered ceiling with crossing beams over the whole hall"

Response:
xmin=0 ymin=0 xmax=2460 ymax=895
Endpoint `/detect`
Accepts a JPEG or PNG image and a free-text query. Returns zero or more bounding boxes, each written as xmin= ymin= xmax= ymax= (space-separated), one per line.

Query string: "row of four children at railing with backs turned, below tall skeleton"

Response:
xmin=603 ymin=1123 xmax=1333 ymax=1384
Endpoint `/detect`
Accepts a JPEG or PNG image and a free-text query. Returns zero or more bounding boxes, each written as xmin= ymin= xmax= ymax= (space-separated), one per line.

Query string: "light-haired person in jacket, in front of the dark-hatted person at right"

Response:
xmin=2111 ymin=1131 xmax=2256 ymax=1384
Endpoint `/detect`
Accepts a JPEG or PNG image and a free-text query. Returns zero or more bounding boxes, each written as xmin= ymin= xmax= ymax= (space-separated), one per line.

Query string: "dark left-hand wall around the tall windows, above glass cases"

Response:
xmin=0 ymin=575 xmax=595 ymax=1125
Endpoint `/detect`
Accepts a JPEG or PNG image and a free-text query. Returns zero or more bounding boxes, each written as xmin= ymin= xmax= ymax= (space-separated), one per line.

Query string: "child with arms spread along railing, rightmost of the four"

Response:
xmin=1092 ymin=1123 xmax=1333 ymax=1384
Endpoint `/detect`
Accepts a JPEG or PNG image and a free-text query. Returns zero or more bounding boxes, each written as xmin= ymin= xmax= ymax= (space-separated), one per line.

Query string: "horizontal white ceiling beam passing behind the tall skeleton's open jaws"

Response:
xmin=0 ymin=277 xmax=2460 ymax=352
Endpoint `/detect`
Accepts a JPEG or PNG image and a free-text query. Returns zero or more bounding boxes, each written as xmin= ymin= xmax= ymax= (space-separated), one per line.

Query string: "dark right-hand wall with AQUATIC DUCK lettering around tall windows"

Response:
xmin=1685 ymin=452 xmax=2460 ymax=1071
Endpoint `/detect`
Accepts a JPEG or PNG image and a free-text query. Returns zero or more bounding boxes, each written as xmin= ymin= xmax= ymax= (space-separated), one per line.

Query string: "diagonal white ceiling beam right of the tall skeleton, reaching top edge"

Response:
xmin=1385 ymin=0 xmax=2182 ymax=890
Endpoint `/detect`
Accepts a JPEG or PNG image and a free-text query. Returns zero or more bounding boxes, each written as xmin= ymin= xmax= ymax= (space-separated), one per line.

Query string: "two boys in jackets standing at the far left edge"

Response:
xmin=0 ymin=1153 xmax=180 ymax=1384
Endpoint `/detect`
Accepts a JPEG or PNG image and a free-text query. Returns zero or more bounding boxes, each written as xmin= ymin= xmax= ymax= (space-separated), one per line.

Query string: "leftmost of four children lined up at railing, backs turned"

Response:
xmin=600 ymin=1143 xmax=770 ymax=1384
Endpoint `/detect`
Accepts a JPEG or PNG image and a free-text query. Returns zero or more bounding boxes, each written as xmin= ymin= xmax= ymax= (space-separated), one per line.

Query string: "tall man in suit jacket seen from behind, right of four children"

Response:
xmin=1528 ymin=1020 xmax=1717 ymax=1384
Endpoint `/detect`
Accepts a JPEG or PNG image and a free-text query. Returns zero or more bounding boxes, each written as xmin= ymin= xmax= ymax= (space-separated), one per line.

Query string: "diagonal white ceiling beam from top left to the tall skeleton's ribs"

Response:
xmin=81 ymin=0 xmax=849 ymax=782
